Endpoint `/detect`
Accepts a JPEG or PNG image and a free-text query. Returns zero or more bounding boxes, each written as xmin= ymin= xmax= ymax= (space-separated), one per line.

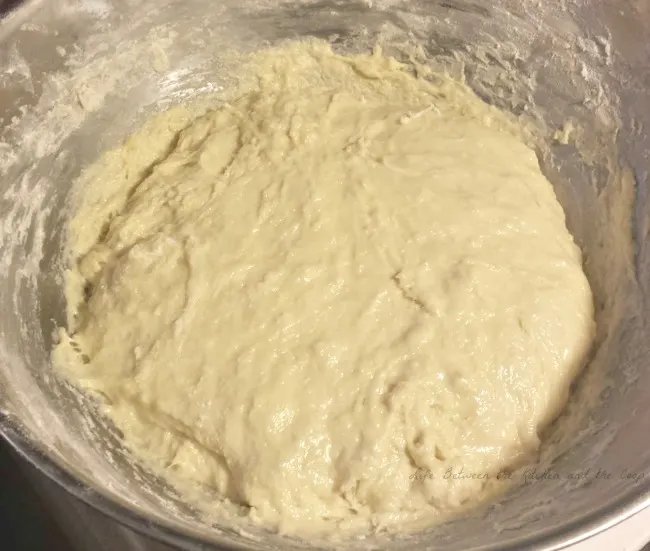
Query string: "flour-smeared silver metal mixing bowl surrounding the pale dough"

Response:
xmin=0 ymin=0 xmax=650 ymax=551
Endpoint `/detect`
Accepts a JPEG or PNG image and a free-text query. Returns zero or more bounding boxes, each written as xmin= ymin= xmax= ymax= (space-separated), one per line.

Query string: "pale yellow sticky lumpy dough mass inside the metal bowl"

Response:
xmin=55 ymin=43 xmax=593 ymax=532
